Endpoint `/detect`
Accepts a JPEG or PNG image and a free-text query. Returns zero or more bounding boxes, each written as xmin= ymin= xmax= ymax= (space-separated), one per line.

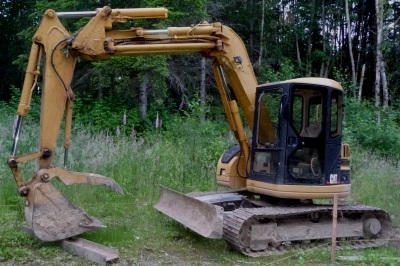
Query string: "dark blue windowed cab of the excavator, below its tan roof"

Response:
xmin=249 ymin=82 xmax=350 ymax=185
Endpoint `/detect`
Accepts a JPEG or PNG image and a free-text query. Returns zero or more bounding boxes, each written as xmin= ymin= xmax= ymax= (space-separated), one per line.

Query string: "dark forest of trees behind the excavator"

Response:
xmin=0 ymin=0 xmax=400 ymax=134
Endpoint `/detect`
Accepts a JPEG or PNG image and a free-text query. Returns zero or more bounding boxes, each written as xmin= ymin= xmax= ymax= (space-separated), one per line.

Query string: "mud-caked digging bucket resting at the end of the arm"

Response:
xmin=25 ymin=183 xmax=105 ymax=241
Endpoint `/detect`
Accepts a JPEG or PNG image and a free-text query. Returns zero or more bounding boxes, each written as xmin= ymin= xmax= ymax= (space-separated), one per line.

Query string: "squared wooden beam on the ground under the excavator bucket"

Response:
xmin=61 ymin=237 xmax=119 ymax=264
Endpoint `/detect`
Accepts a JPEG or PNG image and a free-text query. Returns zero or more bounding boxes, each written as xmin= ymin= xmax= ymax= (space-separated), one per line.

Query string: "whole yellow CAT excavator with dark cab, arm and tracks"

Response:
xmin=8 ymin=6 xmax=391 ymax=256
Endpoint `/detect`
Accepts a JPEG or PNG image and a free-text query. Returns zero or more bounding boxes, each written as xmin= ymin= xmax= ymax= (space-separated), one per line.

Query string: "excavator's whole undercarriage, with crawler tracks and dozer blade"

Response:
xmin=156 ymin=188 xmax=392 ymax=257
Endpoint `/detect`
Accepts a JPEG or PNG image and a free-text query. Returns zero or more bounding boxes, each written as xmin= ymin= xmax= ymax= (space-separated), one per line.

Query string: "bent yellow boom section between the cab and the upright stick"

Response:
xmin=70 ymin=7 xmax=275 ymax=176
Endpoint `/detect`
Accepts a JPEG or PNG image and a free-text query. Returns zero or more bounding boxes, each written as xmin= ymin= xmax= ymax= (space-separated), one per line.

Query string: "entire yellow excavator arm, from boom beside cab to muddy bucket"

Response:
xmin=8 ymin=7 xmax=274 ymax=241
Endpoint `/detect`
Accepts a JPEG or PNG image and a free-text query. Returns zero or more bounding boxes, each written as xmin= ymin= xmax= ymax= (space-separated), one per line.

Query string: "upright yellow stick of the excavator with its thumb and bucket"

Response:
xmin=8 ymin=10 xmax=122 ymax=241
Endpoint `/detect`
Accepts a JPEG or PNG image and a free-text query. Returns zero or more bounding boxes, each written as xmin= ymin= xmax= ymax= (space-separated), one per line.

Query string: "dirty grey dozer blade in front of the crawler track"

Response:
xmin=154 ymin=186 xmax=223 ymax=239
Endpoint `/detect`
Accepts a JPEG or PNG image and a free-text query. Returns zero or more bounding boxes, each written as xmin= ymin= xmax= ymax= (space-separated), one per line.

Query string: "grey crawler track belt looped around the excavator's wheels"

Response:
xmin=223 ymin=205 xmax=392 ymax=257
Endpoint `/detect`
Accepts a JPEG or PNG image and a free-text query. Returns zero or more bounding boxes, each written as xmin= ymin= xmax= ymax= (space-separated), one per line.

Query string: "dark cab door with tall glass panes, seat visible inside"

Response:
xmin=285 ymin=87 xmax=328 ymax=184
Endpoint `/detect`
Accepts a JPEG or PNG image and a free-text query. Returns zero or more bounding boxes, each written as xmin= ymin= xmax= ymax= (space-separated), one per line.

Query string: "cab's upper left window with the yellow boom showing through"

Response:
xmin=257 ymin=89 xmax=282 ymax=146
